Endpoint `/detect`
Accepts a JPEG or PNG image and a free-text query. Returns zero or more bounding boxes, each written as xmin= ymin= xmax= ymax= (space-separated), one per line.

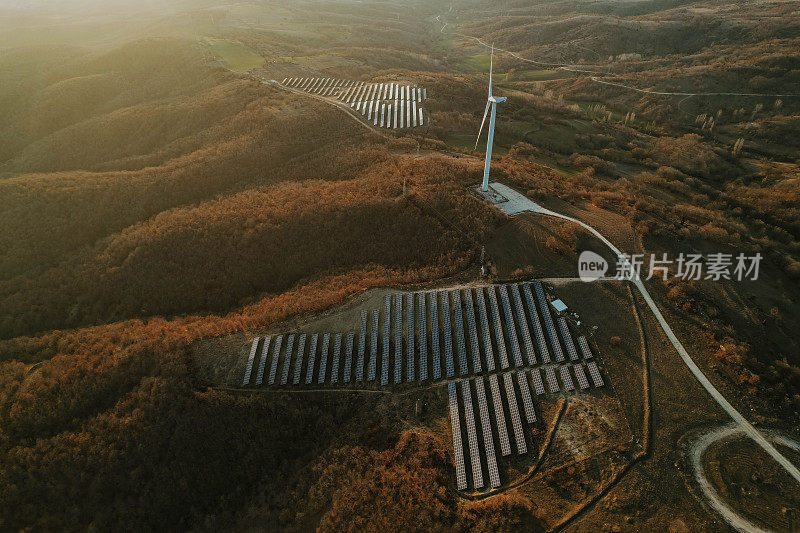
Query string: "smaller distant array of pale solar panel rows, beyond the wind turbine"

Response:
xmin=281 ymin=78 xmax=428 ymax=129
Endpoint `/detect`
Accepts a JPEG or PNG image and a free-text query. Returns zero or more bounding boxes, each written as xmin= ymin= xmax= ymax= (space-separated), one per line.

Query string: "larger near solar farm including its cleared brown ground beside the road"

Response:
xmin=196 ymin=270 xmax=642 ymax=509
